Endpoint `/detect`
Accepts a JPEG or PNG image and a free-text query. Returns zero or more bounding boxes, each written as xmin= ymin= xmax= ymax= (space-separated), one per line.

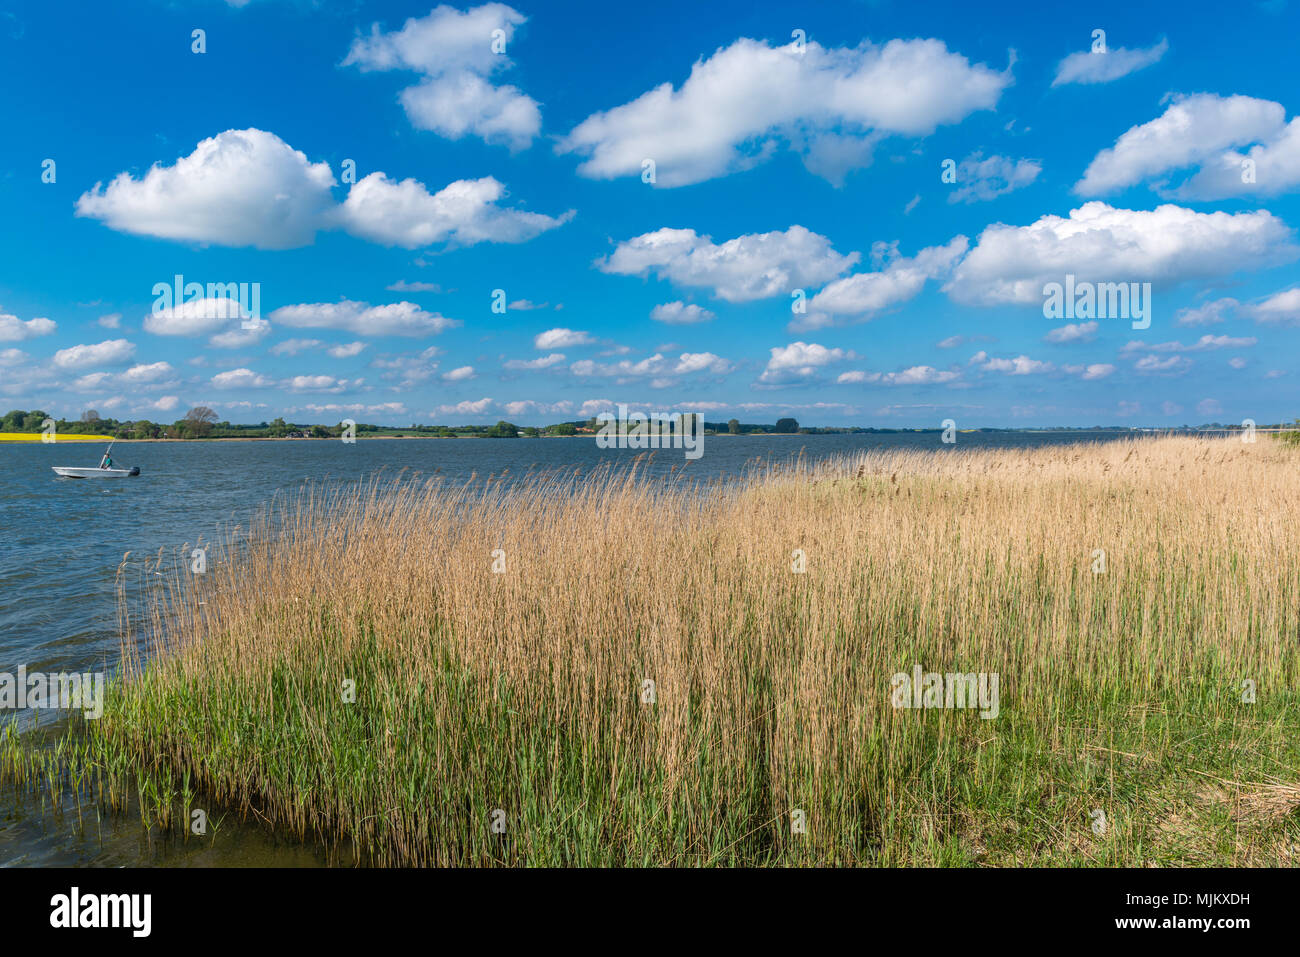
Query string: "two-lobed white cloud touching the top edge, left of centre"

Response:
xmin=343 ymin=3 xmax=542 ymax=150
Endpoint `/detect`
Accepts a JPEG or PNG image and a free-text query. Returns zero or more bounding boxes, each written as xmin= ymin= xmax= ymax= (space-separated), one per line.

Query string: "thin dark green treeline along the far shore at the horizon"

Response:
xmin=0 ymin=406 xmax=1300 ymax=443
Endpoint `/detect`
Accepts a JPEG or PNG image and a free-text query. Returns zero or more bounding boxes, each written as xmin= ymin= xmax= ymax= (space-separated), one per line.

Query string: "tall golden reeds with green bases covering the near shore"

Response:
xmin=0 ymin=438 xmax=1300 ymax=865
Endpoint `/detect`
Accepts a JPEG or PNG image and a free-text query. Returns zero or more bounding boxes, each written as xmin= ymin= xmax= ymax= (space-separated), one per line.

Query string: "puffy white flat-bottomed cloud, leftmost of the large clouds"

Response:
xmin=77 ymin=129 xmax=334 ymax=250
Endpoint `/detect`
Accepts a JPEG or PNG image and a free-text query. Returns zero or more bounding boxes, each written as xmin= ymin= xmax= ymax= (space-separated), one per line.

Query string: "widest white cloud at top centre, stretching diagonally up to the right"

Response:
xmin=556 ymin=38 xmax=1011 ymax=187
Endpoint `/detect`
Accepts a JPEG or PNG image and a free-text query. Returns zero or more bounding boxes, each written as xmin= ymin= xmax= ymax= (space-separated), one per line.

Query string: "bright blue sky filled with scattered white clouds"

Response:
xmin=0 ymin=0 xmax=1300 ymax=428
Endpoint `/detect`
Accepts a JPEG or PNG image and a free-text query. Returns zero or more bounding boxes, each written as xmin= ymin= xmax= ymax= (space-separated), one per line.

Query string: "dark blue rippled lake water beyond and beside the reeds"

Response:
xmin=0 ymin=433 xmax=1127 ymax=866
